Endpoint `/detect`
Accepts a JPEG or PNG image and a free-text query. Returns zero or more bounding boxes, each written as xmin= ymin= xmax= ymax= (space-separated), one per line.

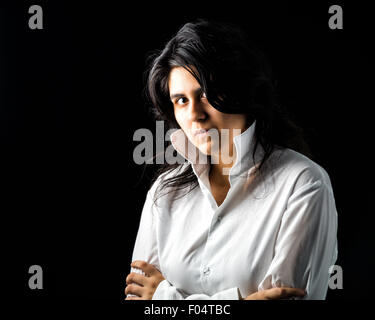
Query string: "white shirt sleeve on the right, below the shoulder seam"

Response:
xmin=258 ymin=180 xmax=337 ymax=300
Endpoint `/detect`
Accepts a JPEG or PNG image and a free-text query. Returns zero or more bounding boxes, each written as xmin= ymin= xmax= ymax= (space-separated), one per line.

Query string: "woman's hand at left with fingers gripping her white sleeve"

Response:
xmin=125 ymin=260 xmax=165 ymax=300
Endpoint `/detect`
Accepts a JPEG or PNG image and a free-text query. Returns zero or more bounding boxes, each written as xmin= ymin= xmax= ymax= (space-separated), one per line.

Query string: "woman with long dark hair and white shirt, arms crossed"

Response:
xmin=125 ymin=20 xmax=337 ymax=300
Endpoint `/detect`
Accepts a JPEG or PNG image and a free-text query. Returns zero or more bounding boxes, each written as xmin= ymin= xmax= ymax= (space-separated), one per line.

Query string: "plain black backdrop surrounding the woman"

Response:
xmin=0 ymin=1 xmax=375 ymax=300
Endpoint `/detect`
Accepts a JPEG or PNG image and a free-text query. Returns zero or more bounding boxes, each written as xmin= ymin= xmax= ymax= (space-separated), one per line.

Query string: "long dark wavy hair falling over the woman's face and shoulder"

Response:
xmin=145 ymin=19 xmax=312 ymax=202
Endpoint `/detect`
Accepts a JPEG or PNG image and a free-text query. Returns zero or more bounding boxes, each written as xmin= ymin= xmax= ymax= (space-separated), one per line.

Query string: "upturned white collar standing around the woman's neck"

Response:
xmin=171 ymin=120 xmax=264 ymax=177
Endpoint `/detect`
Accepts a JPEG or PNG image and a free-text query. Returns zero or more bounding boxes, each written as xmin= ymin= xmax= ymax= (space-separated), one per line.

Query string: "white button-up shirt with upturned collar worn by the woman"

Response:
xmin=131 ymin=122 xmax=338 ymax=300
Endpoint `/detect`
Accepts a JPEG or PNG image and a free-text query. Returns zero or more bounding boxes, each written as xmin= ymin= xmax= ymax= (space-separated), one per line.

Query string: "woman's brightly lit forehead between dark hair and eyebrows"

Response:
xmin=168 ymin=67 xmax=200 ymax=94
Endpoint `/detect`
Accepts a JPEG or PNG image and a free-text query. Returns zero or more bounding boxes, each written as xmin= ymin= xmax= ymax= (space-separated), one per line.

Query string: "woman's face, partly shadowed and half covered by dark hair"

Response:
xmin=168 ymin=67 xmax=248 ymax=155
